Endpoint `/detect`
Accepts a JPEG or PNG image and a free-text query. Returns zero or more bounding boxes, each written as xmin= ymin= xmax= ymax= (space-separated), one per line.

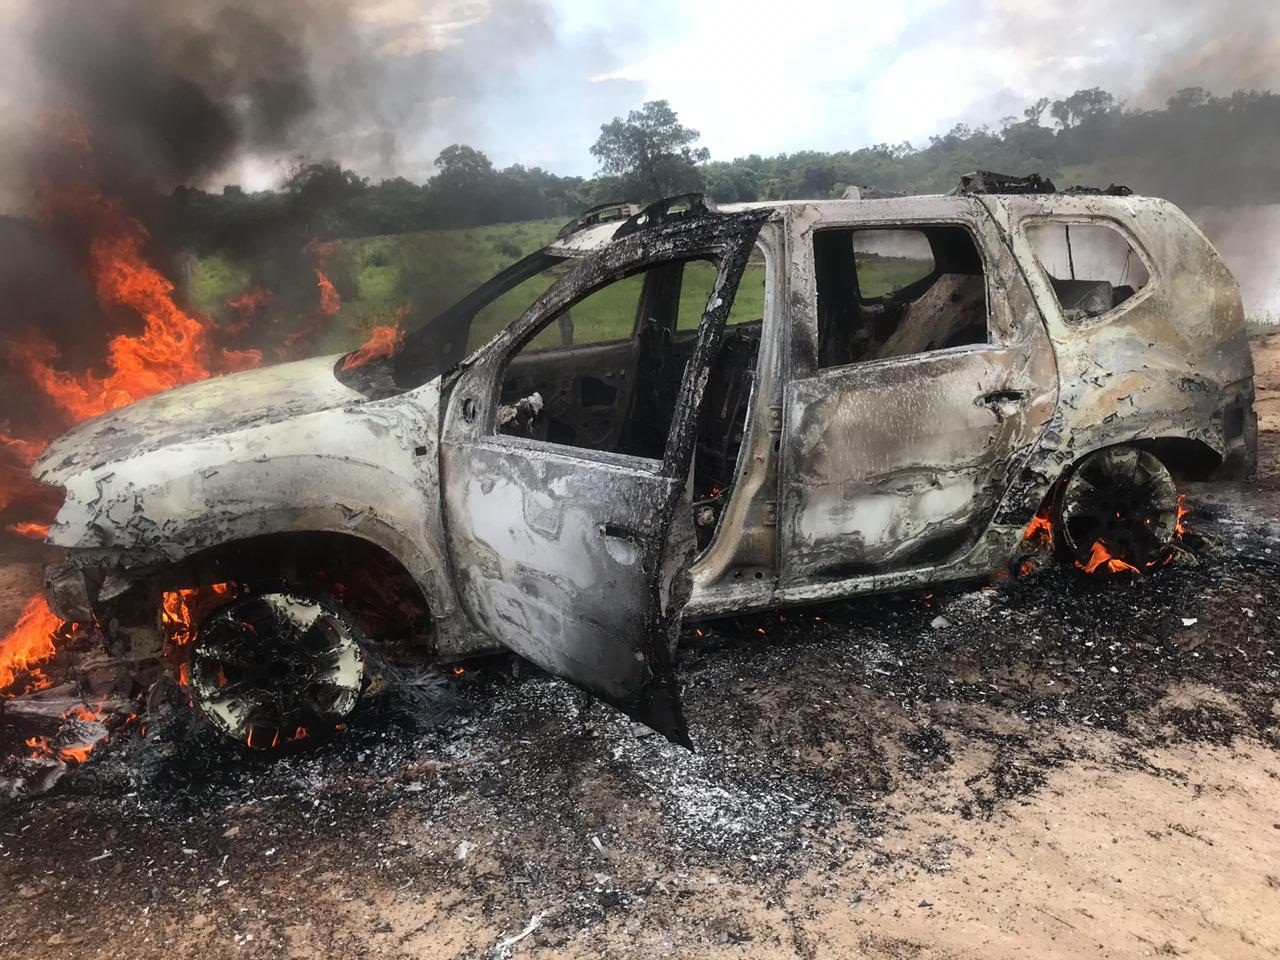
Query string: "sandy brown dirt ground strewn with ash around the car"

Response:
xmin=0 ymin=337 xmax=1280 ymax=960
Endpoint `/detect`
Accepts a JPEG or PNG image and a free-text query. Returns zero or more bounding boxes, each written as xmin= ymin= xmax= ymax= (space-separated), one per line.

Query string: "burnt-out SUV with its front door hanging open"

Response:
xmin=35 ymin=179 xmax=1256 ymax=744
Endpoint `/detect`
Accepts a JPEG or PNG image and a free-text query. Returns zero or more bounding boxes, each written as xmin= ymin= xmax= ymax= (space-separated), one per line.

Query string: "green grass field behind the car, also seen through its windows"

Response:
xmin=186 ymin=220 xmax=922 ymax=353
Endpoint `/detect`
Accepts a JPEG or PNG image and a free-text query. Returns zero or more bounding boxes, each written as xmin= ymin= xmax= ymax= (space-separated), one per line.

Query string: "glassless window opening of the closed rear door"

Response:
xmin=813 ymin=224 xmax=989 ymax=367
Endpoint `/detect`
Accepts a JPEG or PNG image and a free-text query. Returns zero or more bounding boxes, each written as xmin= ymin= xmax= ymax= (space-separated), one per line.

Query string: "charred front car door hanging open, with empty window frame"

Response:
xmin=440 ymin=201 xmax=767 ymax=746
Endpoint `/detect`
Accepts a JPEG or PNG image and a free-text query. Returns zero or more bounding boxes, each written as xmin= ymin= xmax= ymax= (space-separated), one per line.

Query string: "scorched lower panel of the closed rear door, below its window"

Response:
xmin=782 ymin=347 xmax=1038 ymax=585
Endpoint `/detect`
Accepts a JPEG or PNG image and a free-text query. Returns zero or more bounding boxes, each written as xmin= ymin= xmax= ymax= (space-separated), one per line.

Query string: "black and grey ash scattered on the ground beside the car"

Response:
xmin=0 ymin=478 xmax=1280 ymax=950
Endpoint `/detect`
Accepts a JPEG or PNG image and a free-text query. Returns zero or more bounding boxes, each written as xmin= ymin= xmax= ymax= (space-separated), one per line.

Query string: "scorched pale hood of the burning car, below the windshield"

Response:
xmin=32 ymin=356 xmax=365 ymax=484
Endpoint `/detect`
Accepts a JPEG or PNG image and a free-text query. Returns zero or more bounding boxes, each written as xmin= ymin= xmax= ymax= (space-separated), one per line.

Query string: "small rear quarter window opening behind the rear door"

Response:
xmin=1027 ymin=220 xmax=1151 ymax=321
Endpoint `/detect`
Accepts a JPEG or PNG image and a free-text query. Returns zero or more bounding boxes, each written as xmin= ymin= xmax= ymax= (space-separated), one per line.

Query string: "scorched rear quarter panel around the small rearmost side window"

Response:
xmin=1001 ymin=196 xmax=1253 ymax=479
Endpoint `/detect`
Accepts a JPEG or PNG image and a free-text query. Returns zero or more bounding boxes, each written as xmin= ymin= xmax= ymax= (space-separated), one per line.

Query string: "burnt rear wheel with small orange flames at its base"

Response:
xmin=1057 ymin=447 xmax=1178 ymax=573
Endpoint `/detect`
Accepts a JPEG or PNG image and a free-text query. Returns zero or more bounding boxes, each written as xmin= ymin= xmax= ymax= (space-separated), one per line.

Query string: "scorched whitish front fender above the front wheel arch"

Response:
xmin=49 ymin=384 xmax=456 ymax=632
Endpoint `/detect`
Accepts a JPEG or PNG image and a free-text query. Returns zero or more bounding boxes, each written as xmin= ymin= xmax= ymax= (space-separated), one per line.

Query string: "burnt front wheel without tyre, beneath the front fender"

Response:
xmin=189 ymin=588 xmax=365 ymax=749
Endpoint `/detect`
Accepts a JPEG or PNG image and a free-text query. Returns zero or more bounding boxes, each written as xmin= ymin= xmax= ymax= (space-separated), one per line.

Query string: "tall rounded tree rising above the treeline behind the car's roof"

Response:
xmin=591 ymin=100 xmax=710 ymax=200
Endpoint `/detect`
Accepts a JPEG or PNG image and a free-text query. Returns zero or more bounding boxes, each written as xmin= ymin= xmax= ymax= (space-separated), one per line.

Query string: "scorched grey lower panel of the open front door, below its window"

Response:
xmin=445 ymin=438 xmax=689 ymax=739
